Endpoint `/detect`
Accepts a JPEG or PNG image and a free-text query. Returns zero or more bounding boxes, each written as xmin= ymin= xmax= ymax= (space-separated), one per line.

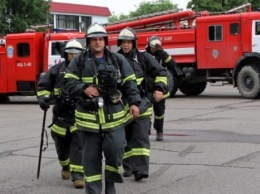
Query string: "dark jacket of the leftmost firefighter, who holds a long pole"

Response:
xmin=37 ymin=61 xmax=77 ymax=136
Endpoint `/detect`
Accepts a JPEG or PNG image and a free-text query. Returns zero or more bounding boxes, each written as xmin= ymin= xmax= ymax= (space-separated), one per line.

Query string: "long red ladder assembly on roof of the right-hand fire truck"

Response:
xmin=105 ymin=10 xmax=204 ymax=33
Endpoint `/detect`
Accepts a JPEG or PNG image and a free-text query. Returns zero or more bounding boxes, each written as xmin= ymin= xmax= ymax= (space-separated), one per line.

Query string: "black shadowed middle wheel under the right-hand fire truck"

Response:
xmin=179 ymin=81 xmax=207 ymax=96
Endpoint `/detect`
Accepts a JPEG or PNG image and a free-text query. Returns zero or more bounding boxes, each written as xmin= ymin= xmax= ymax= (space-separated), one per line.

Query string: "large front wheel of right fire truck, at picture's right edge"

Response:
xmin=237 ymin=65 xmax=260 ymax=99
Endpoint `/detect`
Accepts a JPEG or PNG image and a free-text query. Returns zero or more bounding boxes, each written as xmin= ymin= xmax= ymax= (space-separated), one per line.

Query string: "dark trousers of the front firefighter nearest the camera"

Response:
xmin=81 ymin=127 xmax=126 ymax=194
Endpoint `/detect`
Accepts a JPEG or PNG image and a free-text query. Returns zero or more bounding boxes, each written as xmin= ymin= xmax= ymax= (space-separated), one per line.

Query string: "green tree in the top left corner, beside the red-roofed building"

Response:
xmin=0 ymin=0 xmax=51 ymax=35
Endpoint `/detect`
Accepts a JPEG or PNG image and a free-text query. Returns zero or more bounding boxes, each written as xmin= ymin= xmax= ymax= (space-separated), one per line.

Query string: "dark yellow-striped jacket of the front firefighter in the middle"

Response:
xmin=64 ymin=50 xmax=141 ymax=133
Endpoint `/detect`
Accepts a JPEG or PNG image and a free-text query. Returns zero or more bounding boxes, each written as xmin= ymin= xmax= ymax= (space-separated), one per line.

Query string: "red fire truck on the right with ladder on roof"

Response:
xmin=106 ymin=3 xmax=260 ymax=99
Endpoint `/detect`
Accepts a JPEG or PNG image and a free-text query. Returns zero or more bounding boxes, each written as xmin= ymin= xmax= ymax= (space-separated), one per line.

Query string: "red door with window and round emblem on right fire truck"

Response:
xmin=205 ymin=24 xmax=227 ymax=69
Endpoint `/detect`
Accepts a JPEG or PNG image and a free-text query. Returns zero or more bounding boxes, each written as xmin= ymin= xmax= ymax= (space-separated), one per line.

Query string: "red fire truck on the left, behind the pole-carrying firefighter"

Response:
xmin=0 ymin=26 xmax=85 ymax=101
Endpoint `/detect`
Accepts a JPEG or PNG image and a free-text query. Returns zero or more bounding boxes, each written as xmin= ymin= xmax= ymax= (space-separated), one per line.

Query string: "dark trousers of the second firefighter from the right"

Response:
xmin=123 ymin=116 xmax=151 ymax=175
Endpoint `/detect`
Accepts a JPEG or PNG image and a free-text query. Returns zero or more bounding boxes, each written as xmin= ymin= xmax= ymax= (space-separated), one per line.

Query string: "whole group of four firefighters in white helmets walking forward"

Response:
xmin=37 ymin=23 xmax=175 ymax=194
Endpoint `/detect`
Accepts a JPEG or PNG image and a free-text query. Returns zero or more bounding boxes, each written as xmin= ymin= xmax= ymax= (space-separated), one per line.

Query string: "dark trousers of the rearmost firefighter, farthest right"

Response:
xmin=153 ymin=99 xmax=165 ymax=133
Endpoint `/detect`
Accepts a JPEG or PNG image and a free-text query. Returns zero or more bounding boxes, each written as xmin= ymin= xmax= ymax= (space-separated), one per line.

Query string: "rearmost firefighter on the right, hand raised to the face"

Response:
xmin=146 ymin=35 xmax=176 ymax=141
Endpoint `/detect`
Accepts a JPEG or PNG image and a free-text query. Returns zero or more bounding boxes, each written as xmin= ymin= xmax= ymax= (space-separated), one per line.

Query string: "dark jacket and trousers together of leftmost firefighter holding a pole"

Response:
xmin=37 ymin=61 xmax=83 ymax=181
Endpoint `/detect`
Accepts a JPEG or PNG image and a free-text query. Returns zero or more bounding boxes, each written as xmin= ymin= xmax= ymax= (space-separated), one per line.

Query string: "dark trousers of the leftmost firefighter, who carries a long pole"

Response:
xmin=51 ymin=128 xmax=84 ymax=181
